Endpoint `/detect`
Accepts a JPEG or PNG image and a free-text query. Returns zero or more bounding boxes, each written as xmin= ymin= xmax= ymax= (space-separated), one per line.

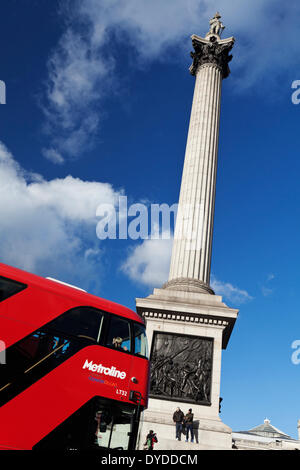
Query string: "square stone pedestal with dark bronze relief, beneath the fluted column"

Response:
xmin=136 ymin=289 xmax=238 ymax=450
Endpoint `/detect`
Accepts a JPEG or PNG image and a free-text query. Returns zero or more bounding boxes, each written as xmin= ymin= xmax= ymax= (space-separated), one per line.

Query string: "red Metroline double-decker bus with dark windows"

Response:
xmin=0 ymin=264 xmax=149 ymax=450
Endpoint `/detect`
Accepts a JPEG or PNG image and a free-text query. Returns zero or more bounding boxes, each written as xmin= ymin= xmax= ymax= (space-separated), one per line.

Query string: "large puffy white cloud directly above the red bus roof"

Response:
xmin=0 ymin=142 xmax=119 ymax=289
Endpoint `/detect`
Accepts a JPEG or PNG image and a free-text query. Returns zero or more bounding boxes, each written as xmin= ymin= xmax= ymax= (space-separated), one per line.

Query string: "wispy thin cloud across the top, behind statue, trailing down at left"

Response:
xmin=44 ymin=0 xmax=300 ymax=163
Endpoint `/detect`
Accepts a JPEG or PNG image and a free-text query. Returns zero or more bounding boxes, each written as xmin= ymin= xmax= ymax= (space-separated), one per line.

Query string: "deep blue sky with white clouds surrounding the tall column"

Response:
xmin=0 ymin=0 xmax=300 ymax=437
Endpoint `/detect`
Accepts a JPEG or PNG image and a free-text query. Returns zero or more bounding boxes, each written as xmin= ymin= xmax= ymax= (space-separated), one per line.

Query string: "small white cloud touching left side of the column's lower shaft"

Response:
xmin=121 ymin=234 xmax=173 ymax=288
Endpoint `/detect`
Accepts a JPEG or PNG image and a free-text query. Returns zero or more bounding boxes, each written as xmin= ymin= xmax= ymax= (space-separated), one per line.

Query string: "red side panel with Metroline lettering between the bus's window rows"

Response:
xmin=0 ymin=346 xmax=149 ymax=449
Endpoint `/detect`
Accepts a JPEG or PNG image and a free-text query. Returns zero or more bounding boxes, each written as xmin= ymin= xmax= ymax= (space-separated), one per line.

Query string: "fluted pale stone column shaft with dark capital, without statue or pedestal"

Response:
xmin=164 ymin=34 xmax=234 ymax=293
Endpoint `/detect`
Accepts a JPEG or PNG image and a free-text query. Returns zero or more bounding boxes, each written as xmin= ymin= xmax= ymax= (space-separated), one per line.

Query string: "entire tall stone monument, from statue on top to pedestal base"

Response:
xmin=136 ymin=13 xmax=238 ymax=450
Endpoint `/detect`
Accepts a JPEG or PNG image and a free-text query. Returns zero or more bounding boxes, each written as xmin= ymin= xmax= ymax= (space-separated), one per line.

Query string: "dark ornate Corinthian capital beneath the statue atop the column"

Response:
xmin=190 ymin=33 xmax=234 ymax=78
